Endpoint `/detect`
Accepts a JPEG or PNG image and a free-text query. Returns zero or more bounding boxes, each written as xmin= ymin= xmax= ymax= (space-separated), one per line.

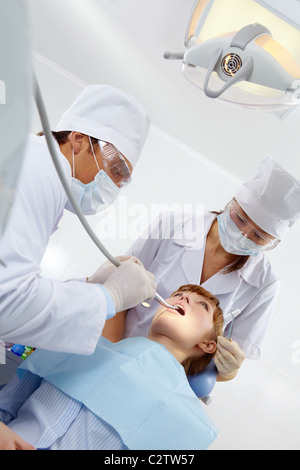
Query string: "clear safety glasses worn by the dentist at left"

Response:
xmin=99 ymin=140 xmax=131 ymax=188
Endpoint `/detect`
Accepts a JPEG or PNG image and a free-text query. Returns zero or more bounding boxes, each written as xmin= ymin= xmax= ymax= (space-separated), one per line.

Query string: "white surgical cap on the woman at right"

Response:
xmin=235 ymin=156 xmax=300 ymax=240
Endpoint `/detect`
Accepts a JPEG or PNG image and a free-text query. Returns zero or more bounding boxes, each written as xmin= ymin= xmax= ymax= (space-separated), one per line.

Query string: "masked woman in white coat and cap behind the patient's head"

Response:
xmin=120 ymin=157 xmax=300 ymax=381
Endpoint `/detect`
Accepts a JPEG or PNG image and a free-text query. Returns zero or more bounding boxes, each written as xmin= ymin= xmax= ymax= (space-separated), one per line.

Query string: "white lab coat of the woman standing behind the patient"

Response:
xmin=125 ymin=213 xmax=280 ymax=359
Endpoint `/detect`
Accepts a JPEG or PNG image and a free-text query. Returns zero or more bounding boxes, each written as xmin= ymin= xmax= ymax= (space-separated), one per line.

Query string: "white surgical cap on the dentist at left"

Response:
xmin=55 ymin=85 xmax=150 ymax=167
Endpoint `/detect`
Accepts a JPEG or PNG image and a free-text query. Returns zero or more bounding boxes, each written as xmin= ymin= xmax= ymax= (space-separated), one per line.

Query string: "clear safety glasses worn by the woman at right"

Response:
xmin=226 ymin=199 xmax=280 ymax=251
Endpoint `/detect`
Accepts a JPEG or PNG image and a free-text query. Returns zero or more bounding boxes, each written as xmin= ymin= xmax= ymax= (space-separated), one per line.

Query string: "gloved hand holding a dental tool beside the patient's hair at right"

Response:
xmin=214 ymin=336 xmax=246 ymax=382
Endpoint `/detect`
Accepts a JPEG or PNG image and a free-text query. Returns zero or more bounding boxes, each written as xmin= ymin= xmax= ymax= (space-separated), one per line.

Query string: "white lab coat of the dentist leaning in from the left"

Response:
xmin=0 ymin=136 xmax=111 ymax=354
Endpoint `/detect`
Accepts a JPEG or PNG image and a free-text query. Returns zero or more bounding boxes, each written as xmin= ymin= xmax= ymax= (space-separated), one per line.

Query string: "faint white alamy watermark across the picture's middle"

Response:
xmin=96 ymin=196 xmax=204 ymax=246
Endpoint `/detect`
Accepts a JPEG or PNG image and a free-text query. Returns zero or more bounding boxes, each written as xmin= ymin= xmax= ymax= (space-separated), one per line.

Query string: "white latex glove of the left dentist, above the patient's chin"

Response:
xmin=103 ymin=258 xmax=157 ymax=312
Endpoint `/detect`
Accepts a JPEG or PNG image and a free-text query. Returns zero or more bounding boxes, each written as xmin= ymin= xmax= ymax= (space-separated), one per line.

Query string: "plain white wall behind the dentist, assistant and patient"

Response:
xmin=32 ymin=53 xmax=300 ymax=450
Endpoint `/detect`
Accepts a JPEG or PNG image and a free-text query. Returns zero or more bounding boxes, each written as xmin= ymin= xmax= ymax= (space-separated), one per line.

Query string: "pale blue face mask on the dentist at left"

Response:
xmin=66 ymin=141 xmax=120 ymax=215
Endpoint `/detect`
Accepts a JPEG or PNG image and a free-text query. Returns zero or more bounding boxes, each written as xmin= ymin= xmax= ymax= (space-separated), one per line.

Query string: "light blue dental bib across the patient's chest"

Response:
xmin=18 ymin=338 xmax=217 ymax=450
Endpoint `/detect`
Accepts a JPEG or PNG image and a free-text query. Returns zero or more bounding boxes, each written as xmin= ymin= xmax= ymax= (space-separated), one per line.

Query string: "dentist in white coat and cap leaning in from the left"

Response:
xmin=0 ymin=85 xmax=156 ymax=354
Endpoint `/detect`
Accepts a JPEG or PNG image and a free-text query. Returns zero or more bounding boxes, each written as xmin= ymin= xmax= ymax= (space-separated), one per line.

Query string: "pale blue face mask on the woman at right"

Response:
xmin=218 ymin=209 xmax=261 ymax=256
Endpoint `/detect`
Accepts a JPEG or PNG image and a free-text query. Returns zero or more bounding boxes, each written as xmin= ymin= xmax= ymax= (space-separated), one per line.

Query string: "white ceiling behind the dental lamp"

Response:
xmin=27 ymin=0 xmax=300 ymax=180
